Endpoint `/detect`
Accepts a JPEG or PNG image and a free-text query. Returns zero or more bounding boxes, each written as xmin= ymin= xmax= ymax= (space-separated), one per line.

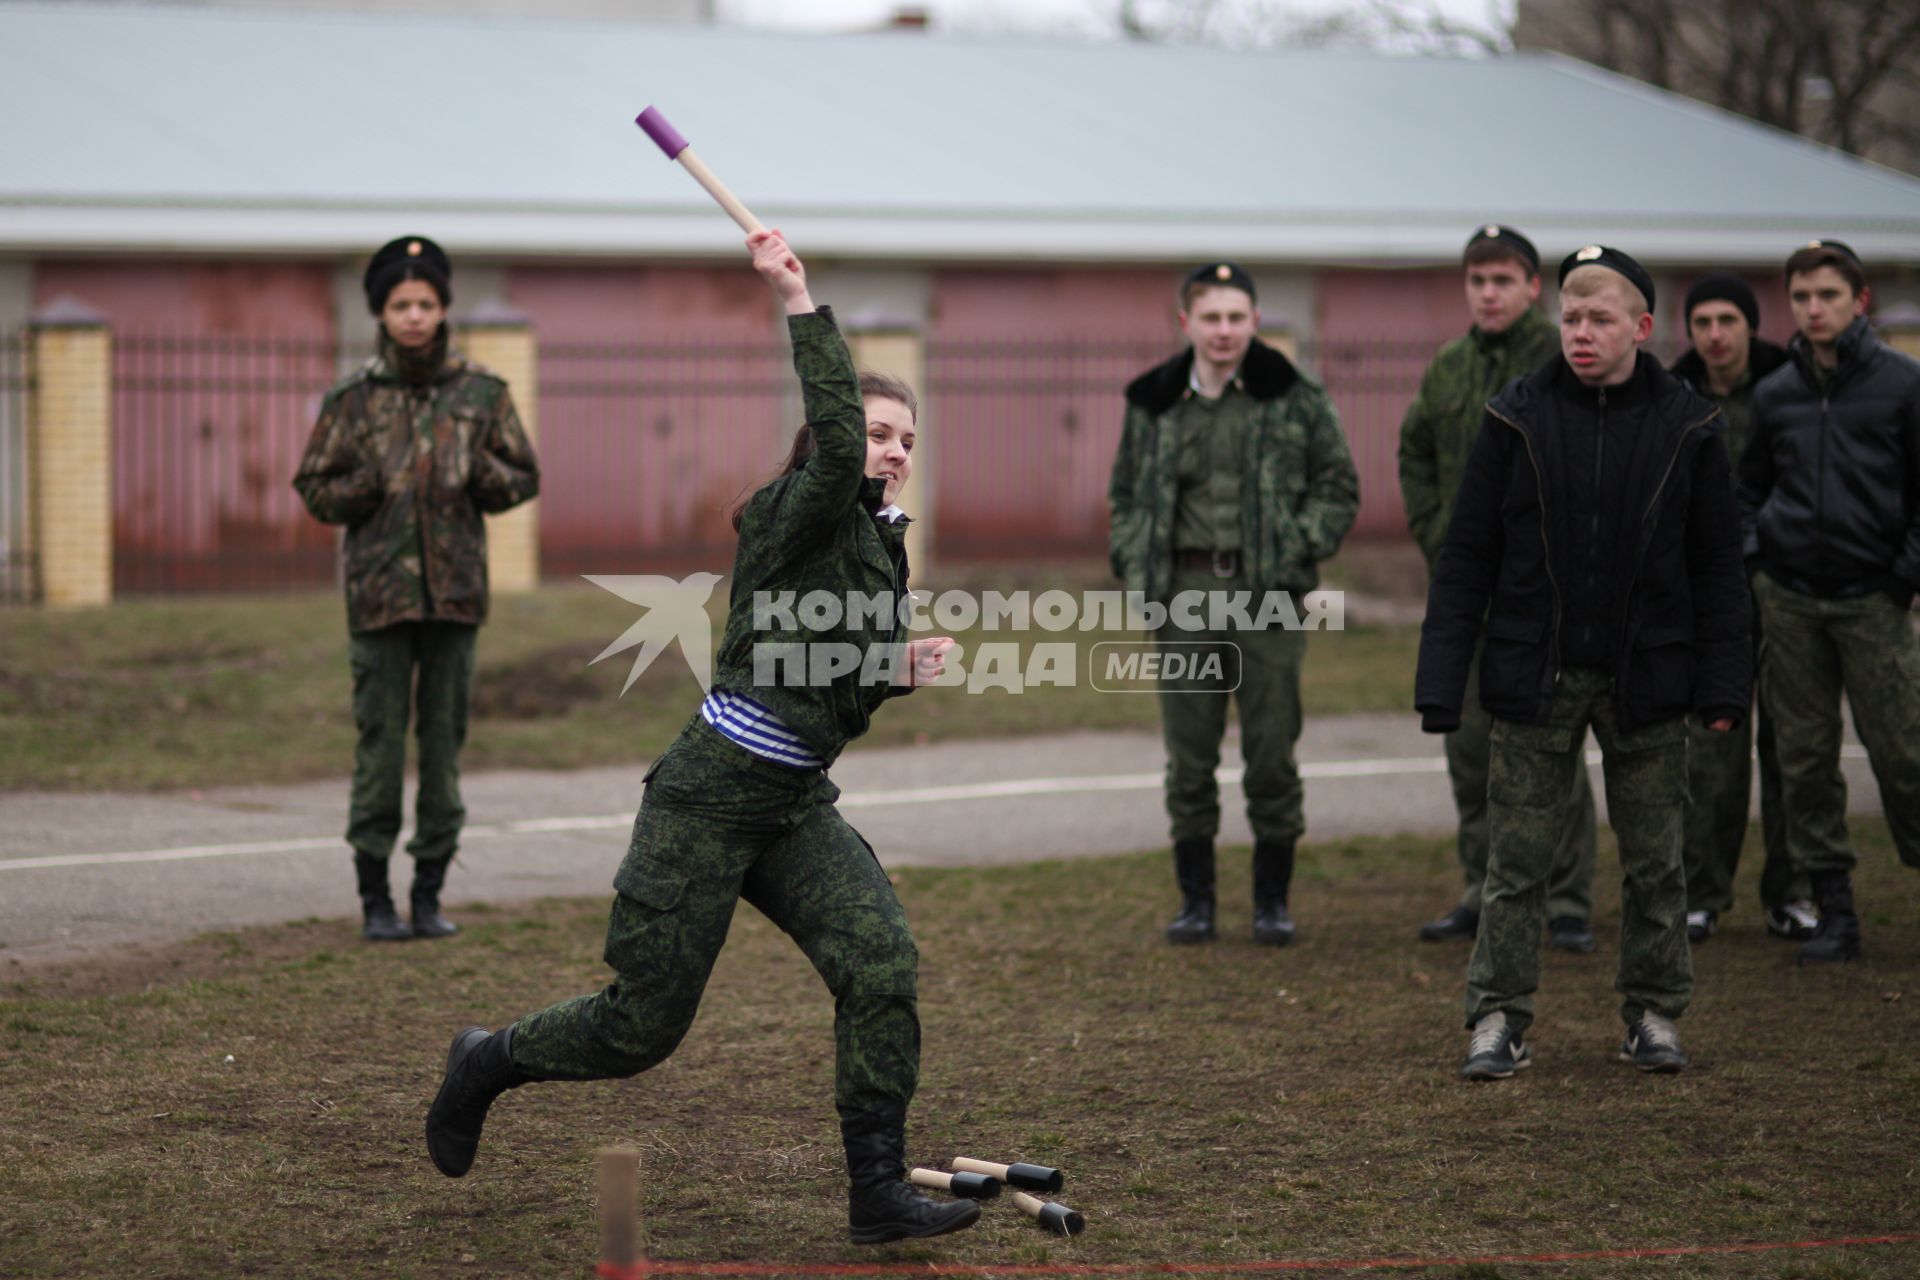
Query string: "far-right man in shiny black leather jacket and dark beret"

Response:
xmin=1740 ymin=240 xmax=1920 ymax=963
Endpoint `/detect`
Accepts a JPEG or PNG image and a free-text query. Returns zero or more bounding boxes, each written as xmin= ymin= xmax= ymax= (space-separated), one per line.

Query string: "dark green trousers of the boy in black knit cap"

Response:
xmin=1684 ymin=608 xmax=1812 ymax=912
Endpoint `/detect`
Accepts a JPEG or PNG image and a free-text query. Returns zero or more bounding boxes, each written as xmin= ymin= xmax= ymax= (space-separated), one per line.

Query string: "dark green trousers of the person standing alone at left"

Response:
xmin=348 ymin=622 xmax=478 ymax=862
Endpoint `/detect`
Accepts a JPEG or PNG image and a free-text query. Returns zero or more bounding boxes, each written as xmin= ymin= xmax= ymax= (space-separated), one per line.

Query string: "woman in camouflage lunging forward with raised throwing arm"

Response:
xmin=426 ymin=232 xmax=979 ymax=1244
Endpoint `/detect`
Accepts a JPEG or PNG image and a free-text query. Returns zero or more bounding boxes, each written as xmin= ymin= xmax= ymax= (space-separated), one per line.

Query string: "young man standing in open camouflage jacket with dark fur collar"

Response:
xmin=1108 ymin=263 xmax=1359 ymax=946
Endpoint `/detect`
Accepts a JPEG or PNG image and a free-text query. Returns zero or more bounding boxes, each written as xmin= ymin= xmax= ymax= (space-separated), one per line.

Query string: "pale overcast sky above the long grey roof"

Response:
xmin=716 ymin=0 xmax=1507 ymax=36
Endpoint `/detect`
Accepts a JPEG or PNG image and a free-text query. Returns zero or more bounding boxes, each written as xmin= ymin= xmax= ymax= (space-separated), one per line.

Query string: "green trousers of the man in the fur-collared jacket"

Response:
xmin=1154 ymin=568 xmax=1308 ymax=841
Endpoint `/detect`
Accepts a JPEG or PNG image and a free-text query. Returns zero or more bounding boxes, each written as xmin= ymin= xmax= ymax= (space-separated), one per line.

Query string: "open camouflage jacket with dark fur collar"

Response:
xmin=1106 ymin=338 xmax=1359 ymax=603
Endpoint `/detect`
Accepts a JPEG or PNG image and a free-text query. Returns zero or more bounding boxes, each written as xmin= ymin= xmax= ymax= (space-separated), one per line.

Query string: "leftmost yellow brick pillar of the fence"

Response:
xmin=27 ymin=297 xmax=113 ymax=606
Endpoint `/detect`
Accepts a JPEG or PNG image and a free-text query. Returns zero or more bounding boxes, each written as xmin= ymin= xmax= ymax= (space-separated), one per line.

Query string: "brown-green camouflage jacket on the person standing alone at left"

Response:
xmin=294 ymin=330 xmax=540 ymax=631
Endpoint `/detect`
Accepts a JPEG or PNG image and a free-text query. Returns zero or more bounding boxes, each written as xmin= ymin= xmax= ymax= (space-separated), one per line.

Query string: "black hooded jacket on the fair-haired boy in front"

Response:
xmin=1415 ymin=353 xmax=1753 ymax=733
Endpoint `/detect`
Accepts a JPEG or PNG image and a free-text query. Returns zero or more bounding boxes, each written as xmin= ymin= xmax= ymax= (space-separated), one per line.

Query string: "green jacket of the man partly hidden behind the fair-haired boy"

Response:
xmin=1400 ymin=307 xmax=1559 ymax=566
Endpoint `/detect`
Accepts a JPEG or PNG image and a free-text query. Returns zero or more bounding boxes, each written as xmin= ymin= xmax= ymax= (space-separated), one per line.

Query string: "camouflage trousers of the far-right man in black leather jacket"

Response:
xmin=1753 ymin=572 xmax=1920 ymax=873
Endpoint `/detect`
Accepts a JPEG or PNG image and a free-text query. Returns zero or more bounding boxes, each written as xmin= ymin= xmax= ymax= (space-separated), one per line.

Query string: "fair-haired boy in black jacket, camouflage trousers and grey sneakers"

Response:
xmin=1415 ymin=246 xmax=1753 ymax=1080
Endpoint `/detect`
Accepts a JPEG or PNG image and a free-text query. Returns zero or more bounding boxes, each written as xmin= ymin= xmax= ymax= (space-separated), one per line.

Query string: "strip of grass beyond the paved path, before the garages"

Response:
xmin=0 ymin=568 xmax=1419 ymax=791
